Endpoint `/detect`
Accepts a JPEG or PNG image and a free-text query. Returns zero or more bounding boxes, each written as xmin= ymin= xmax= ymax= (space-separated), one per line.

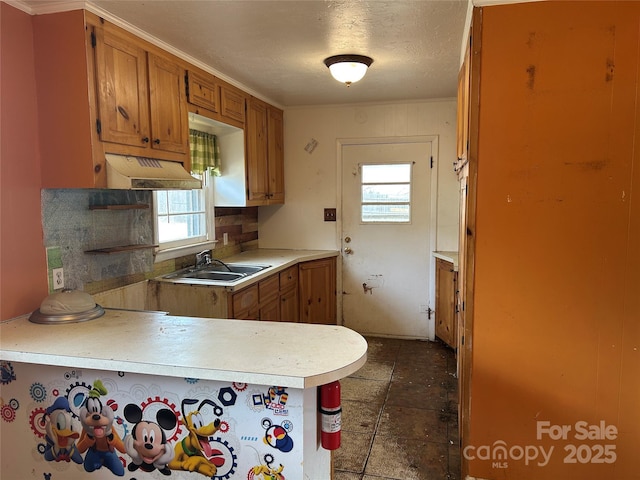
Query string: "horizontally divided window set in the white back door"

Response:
xmin=360 ymin=163 xmax=412 ymax=224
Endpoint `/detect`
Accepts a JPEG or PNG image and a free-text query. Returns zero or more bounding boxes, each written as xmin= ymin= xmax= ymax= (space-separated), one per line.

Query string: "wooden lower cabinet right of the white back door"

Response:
xmin=436 ymin=258 xmax=458 ymax=348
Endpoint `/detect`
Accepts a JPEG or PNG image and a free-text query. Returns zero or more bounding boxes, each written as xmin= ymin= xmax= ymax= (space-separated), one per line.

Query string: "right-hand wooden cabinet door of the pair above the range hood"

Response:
xmin=148 ymin=53 xmax=189 ymax=153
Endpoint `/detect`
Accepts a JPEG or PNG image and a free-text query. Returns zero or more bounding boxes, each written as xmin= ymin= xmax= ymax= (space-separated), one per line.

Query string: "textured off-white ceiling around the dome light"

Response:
xmin=17 ymin=0 xmax=468 ymax=107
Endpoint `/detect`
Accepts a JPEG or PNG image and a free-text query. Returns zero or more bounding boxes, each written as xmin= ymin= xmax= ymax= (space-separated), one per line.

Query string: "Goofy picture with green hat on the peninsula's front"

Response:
xmin=78 ymin=380 xmax=125 ymax=477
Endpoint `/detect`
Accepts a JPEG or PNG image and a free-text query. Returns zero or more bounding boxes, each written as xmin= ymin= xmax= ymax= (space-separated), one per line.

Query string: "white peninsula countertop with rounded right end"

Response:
xmin=0 ymin=309 xmax=367 ymax=388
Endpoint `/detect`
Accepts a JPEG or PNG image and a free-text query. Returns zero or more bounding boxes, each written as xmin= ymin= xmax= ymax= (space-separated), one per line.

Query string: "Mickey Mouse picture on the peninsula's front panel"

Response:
xmin=124 ymin=403 xmax=178 ymax=475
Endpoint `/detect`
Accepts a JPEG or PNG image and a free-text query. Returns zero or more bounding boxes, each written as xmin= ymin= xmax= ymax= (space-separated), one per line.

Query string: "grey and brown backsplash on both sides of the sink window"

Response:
xmin=41 ymin=189 xmax=258 ymax=294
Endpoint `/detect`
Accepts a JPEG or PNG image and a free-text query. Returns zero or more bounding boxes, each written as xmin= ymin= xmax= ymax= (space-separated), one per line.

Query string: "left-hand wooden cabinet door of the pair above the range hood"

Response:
xmin=95 ymin=24 xmax=149 ymax=147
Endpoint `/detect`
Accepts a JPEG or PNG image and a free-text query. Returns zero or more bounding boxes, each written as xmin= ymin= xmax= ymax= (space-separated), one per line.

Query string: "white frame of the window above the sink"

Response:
xmin=153 ymin=171 xmax=215 ymax=263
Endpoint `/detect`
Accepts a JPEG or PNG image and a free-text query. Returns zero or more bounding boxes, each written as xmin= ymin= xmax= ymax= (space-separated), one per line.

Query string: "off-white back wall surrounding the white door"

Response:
xmin=258 ymin=100 xmax=458 ymax=250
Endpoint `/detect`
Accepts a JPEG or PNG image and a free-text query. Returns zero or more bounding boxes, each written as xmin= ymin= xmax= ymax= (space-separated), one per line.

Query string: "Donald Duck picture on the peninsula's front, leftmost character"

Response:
xmin=43 ymin=397 xmax=82 ymax=463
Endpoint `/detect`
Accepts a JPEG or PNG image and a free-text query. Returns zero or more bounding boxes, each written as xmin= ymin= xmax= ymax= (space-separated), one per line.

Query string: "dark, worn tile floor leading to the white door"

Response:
xmin=334 ymin=337 xmax=460 ymax=480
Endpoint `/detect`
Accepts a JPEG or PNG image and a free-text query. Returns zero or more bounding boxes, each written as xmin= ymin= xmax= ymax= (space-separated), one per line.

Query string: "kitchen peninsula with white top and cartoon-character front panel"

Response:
xmin=0 ymin=309 xmax=367 ymax=480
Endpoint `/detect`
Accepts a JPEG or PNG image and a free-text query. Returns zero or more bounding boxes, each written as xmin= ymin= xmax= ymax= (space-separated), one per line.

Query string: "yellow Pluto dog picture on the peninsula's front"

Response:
xmin=169 ymin=398 xmax=224 ymax=477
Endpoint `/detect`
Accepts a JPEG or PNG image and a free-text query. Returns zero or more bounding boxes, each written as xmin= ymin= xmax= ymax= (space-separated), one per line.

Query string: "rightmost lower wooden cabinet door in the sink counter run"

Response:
xmin=298 ymin=258 xmax=336 ymax=325
